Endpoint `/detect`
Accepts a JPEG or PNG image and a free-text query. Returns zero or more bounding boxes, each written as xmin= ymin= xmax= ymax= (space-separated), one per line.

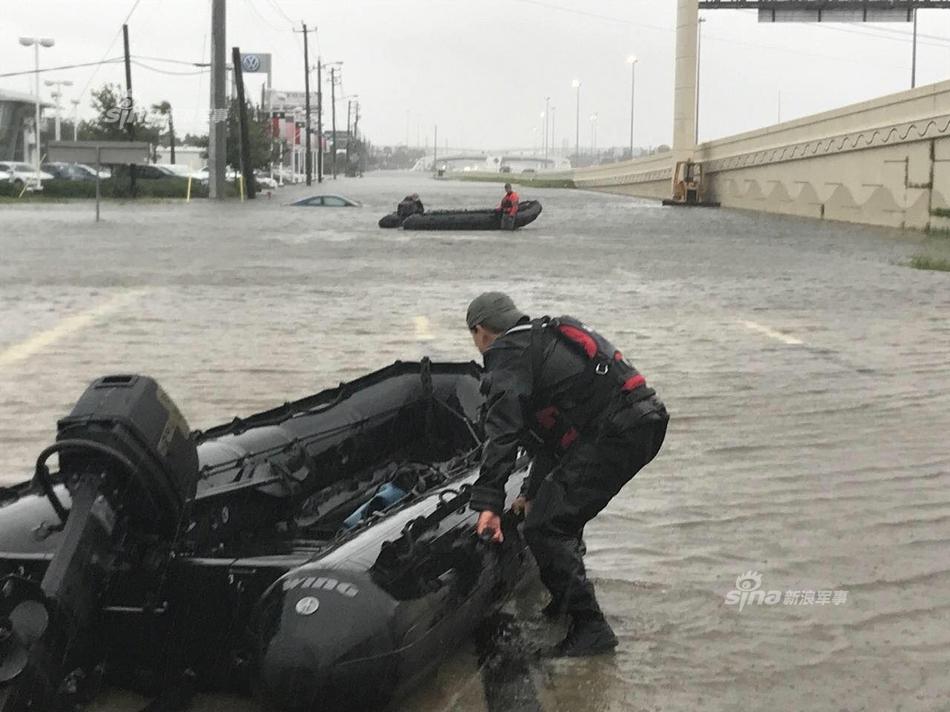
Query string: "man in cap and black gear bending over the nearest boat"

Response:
xmin=466 ymin=292 xmax=669 ymax=656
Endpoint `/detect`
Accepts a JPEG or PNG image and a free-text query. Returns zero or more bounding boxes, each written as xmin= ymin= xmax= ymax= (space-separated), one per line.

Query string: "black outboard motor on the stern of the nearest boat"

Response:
xmin=0 ymin=376 xmax=198 ymax=712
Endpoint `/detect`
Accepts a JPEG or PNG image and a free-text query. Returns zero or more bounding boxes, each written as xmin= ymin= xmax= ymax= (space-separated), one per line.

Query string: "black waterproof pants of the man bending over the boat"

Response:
xmin=524 ymin=400 xmax=669 ymax=620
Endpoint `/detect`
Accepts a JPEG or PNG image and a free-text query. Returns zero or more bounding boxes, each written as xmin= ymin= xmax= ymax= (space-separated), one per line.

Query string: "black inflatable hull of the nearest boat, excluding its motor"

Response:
xmin=0 ymin=361 xmax=527 ymax=712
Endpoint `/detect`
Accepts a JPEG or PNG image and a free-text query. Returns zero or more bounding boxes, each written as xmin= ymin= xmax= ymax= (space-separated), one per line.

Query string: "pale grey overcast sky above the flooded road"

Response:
xmin=0 ymin=0 xmax=950 ymax=148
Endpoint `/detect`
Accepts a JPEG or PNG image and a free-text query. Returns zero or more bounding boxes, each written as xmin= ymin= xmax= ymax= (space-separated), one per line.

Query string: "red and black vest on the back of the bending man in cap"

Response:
xmin=531 ymin=316 xmax=656 ymax=450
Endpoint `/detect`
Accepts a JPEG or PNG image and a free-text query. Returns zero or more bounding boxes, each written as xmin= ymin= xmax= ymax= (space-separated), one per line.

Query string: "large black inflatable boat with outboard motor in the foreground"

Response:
xmin=0 ymin=361 xmax=525 ymax=712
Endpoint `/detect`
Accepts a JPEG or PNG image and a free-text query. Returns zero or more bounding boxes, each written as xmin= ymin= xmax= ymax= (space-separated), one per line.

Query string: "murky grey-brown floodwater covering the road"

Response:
xmin=0 ymin=174 xmax=950 ymax=712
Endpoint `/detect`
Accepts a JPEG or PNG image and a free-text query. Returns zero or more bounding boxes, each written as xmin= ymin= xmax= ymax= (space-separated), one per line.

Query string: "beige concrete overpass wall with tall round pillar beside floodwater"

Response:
xmin=570 ymin=0 xmax=950 ymax=230
